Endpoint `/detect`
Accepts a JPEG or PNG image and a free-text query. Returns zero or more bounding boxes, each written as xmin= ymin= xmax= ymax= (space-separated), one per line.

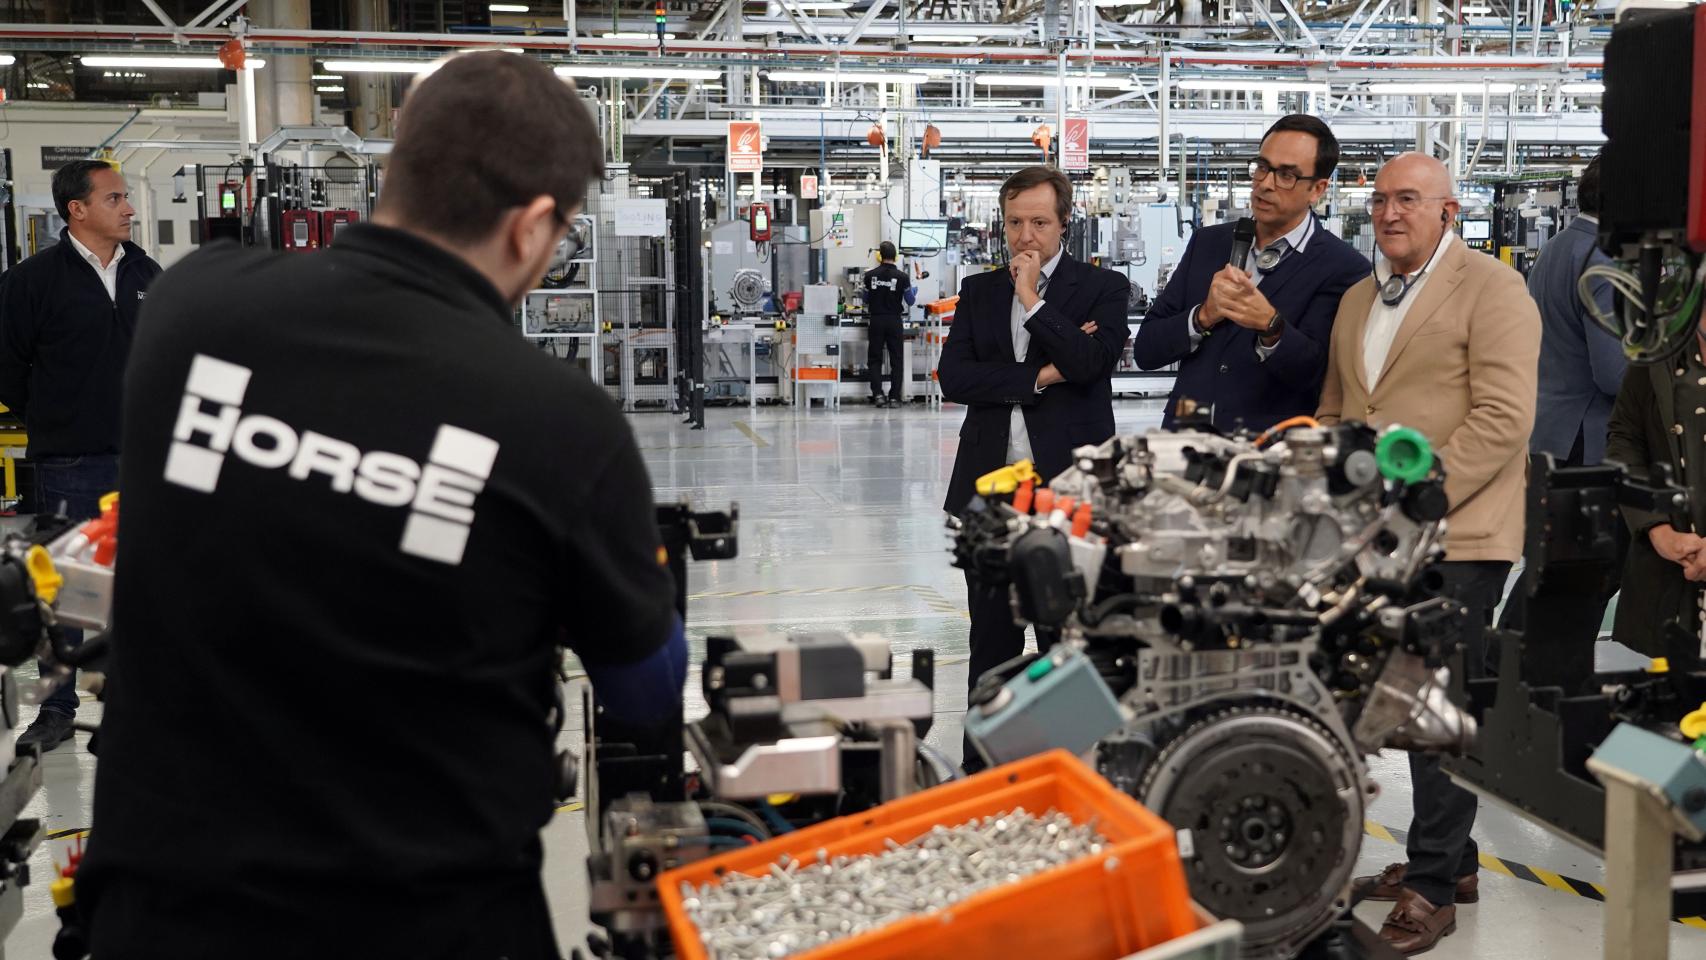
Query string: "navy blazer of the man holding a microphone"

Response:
xmin=1131 ymin=213 xmax=1368 ymax=431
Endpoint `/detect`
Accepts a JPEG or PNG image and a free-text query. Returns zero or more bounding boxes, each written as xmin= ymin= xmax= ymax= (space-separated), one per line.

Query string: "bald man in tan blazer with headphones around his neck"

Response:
xmin=1315 ymin=153 xmax=1541 ymax=953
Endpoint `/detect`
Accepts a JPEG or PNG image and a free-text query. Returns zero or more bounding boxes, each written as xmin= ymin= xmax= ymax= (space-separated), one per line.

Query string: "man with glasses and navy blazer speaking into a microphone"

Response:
xmin=1131 ymin=114 xmax=1368 ymax=431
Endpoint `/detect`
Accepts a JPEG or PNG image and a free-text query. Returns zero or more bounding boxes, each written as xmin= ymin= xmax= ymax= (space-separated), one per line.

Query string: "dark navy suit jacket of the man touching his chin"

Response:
xmin=938 ymin=256 xmax=1131 ymax=513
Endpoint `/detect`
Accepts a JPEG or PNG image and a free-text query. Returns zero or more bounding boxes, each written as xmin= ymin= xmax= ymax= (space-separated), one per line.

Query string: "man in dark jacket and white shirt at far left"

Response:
xmin=0 ymin=160 xmax=160 ymax=750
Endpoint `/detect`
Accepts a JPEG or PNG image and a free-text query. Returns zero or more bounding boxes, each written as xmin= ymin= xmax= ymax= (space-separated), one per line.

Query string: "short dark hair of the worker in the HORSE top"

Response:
xmin=379 ymin=51 xmax=604 ymax=242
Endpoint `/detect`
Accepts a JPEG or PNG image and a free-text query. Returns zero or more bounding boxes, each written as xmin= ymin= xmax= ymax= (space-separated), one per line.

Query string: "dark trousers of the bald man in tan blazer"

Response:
xmin=1404 ymin=561 xmax=1510 ymax=907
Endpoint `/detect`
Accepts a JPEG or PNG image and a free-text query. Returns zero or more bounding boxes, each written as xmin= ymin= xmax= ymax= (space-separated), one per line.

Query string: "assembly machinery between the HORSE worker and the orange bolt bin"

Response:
xmin=576 ymin=503 xmax=952 ymax=960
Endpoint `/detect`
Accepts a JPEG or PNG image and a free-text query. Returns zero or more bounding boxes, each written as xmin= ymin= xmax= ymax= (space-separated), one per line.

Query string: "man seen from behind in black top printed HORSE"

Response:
xmin=77 ymin=51 xmax=688 ymax=960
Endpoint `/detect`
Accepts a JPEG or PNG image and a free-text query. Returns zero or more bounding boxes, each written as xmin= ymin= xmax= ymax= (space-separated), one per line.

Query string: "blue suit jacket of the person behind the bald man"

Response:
xmin=1529 ymin=218 xmax=1629 ymax=464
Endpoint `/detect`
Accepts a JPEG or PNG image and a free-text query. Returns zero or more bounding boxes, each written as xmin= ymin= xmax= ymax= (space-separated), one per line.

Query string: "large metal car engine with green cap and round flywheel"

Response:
xmin=950 ymin=421 xmax=1474 ymax=958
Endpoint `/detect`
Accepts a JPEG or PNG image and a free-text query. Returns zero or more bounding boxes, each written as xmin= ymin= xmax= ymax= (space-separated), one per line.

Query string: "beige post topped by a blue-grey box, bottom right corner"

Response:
xmin=1588 ymin=723 xmax=1706 ymax=960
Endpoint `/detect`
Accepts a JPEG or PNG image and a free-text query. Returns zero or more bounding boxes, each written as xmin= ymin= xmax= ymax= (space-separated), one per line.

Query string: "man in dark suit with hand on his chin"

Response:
xmin=938 ymin=167 xmax=1131 ymax=771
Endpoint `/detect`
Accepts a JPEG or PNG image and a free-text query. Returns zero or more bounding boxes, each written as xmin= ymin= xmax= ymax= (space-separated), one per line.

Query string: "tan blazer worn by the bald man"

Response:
xmin=1315 ymin=240 xmax=1541 ymax=561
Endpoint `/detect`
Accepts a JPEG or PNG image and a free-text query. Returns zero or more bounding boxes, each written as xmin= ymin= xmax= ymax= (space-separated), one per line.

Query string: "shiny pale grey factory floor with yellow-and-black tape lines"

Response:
xmin=3 ymin=401 xmax=1706 ymax=960
